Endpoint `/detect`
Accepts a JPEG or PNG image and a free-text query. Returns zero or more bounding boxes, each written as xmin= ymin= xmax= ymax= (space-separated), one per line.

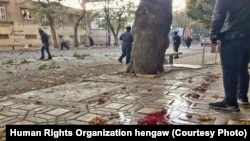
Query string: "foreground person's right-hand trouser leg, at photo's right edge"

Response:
xmin=237 ymin=41 xmax=250 ymax=104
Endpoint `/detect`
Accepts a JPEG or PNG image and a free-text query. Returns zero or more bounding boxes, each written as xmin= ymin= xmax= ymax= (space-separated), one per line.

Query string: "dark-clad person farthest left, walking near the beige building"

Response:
xmin=38 ymin=28 xmax=52 ymax=60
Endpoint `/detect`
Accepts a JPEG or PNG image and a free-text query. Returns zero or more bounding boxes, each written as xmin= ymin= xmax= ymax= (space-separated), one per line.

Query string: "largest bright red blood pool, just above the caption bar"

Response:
xmin=138 ymin=110 xmax=170 ymax=125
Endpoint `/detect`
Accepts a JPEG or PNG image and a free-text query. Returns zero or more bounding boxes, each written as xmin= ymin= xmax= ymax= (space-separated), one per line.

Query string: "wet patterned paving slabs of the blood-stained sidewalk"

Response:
xmin=0 ymin=45 xmax=250 ymax=127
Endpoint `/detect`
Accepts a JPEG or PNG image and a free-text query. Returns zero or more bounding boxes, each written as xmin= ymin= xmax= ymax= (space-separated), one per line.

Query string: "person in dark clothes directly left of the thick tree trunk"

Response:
xmin=118 ymin=26 xmax=134 ymax=64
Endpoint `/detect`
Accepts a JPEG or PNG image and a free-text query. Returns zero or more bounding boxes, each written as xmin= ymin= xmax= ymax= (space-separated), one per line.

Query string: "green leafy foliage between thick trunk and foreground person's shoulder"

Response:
xmin=186 ymin=0 xmax=215 ymax=30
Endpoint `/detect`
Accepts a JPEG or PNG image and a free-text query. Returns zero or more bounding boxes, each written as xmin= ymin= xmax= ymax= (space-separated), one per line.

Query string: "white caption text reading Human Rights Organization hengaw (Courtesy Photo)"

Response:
xmin=9 ymin=128 xmax=247 ymax=138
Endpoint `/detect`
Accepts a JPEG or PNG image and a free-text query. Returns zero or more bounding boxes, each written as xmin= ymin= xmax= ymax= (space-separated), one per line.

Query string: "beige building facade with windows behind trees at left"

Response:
xmin=0 ymin=0 xmax=86 ymax=47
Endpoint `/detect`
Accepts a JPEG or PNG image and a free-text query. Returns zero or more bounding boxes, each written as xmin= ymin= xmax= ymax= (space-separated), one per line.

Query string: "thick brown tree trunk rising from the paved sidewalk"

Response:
xmin=126 ymin=0 xmax=172 ymax=74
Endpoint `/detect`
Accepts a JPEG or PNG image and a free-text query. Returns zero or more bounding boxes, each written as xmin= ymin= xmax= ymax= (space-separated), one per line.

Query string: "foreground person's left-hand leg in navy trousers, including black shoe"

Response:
xmin=209 ymin=40 xmax=244 ymax=110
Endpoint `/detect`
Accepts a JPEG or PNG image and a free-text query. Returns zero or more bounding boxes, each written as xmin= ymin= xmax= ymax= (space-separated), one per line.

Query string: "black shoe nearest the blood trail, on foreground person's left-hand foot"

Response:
xmin=209 ymin=101 xmax=240 ymax=111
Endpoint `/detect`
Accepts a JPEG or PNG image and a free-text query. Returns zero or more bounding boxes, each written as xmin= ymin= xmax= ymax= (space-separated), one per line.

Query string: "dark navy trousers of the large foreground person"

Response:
xmin=220 ymin=39 xmax=250 ymax=106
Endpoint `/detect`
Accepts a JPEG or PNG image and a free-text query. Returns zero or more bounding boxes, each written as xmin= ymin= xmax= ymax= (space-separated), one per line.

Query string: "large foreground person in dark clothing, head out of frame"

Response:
xmin=209 ymin=0 xmax=250 ymax=111
